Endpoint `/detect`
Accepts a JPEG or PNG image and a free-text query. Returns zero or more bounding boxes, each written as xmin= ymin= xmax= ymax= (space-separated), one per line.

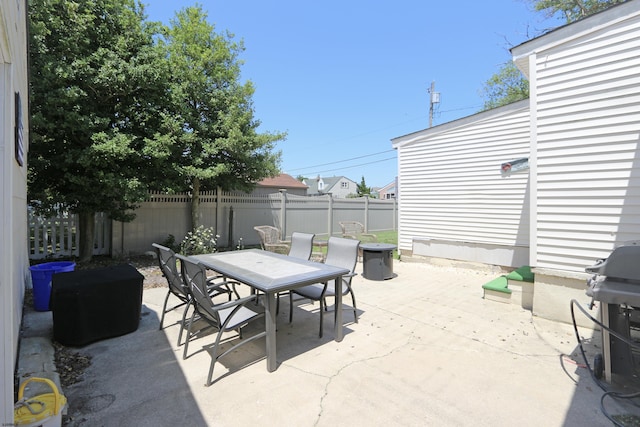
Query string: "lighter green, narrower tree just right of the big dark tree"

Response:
xmin=157 ymin=5 xmax=285 ymax=229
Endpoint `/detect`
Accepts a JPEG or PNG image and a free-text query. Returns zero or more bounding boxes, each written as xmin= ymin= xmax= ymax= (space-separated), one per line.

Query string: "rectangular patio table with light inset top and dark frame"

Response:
xmin=191 ymin=249 xmax=349 ymax=372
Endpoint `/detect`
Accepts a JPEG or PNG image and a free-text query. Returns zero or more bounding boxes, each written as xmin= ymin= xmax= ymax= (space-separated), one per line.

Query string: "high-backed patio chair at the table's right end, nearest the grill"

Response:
xmin=289 ymin=237 xmax=360 ymax=338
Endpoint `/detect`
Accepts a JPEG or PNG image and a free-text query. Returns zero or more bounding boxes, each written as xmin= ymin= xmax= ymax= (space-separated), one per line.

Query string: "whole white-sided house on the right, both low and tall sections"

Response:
xmin=393 ymin=0 xmax=640 ymax=321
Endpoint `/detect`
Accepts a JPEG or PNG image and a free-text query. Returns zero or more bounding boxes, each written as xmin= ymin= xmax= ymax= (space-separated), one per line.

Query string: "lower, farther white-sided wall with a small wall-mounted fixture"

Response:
xmin=393 ymin=101 xmax=529 ymax=267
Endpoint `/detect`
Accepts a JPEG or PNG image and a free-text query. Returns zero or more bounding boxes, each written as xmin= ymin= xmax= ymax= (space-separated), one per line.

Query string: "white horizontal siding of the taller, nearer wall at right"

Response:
xmin=535 ymin=18 xmax=640 ymax=271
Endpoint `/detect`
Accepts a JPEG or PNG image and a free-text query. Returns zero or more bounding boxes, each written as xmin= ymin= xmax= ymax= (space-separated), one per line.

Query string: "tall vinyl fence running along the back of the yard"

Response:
xmin=29 ymin=191 xmax=398 ymax=259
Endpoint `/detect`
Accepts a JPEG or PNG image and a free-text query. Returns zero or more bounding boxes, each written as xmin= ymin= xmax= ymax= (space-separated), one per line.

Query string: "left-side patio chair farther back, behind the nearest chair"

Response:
xmin=152 ymin=243 xmax=240 ymax=346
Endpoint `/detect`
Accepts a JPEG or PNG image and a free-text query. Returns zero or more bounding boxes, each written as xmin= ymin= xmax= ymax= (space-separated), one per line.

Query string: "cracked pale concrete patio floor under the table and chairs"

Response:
xmin=21 ymin=261 xmax=638 ymax=426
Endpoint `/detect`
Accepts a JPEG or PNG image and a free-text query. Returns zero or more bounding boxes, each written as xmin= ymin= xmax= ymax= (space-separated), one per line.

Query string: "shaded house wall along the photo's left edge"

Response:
xmin=0 ymin=0 xmax=31 ymax=426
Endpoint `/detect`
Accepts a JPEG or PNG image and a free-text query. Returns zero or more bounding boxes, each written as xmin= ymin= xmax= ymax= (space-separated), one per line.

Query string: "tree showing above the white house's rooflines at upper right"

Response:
xmin=482 ymin=0 xmax=626 ymax=110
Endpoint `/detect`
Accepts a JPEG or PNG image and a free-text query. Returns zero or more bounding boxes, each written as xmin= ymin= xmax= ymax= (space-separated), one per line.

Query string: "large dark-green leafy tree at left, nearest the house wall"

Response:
xmin=28 ymin=0 xmax=164 ymax=261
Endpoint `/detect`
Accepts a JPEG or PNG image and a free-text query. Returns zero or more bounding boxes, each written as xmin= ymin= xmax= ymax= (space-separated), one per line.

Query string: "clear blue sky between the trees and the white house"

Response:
xmin=142 ymin=0 xmax=562 ymax=187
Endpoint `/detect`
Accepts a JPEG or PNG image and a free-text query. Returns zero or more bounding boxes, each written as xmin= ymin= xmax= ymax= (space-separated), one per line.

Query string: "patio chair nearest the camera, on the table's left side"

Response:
xmin=176 ymin=255 xmax=267 ymax=387
